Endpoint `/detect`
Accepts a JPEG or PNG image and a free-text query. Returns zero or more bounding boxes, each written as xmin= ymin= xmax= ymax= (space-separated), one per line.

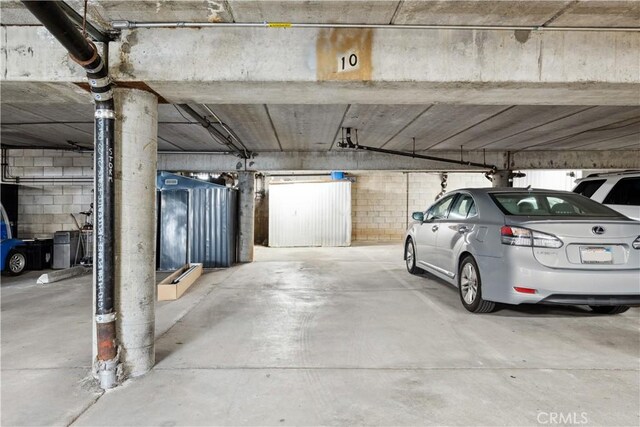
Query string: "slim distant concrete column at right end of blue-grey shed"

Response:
xmin=238 ymin=172 xmax=256 ymax=262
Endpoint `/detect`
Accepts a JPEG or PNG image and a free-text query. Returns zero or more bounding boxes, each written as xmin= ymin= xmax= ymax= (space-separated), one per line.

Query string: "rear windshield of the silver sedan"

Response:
xmin=491 ymin=192 xmax=622 ymax=217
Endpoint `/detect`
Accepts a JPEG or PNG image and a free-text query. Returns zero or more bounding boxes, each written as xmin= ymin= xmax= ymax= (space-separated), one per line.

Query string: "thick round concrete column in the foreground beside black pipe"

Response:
xmin=115 ymin=89 xmax=158 ymax=378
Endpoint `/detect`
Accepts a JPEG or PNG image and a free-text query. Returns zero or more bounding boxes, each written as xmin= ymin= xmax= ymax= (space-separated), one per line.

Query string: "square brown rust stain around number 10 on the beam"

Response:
xmin=316 ymin=28 xmax=373 ymax=81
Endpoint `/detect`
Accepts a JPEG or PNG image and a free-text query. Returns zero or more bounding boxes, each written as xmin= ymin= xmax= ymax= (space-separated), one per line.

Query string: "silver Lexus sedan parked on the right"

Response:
xmin=404 ymin=188 xmax=640 ymax=314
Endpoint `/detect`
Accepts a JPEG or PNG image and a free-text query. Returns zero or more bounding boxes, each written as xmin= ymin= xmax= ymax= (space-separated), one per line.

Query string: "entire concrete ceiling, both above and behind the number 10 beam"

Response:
xmin=0 ymin=0 xmax=640 ymax=155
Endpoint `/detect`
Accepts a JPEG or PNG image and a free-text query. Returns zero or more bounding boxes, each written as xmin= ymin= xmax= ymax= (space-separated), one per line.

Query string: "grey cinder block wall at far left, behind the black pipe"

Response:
xmin=6 ymin=149 xmax=93 ymax=239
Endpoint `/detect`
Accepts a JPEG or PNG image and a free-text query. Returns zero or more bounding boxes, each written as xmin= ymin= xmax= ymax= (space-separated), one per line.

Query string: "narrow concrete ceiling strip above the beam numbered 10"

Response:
xmin=0 ymin=0 xmax=640 ymax=29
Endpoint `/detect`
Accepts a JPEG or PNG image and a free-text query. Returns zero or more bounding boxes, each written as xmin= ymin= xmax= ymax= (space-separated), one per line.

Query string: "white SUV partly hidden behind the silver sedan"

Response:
xmin=573 ymin=171 xmax=640 ymax=221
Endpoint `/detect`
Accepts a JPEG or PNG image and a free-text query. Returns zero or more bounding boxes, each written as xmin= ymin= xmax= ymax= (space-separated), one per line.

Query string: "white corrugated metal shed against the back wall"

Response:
xmin=269 ymin=181 xmax=351 ymax=247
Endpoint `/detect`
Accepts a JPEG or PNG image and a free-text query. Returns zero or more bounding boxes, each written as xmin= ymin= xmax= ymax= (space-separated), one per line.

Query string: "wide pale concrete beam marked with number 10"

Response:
xmin=0 ymin=27 xmax=640 ymax=105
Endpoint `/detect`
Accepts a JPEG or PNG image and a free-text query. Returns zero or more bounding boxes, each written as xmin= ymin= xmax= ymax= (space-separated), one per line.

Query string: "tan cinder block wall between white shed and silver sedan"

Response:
xmin=349 ymin=172 xmax=491 ymax=241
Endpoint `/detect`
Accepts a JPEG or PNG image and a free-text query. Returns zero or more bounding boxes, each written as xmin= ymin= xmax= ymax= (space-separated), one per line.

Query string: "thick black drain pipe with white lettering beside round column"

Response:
xmin=22 ymin=1 xmax=118 ymax=389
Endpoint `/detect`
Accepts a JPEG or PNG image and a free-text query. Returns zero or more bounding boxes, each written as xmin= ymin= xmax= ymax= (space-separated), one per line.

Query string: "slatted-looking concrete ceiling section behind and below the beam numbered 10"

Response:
xmin=1 ymin=104 xmax=640 ymax=151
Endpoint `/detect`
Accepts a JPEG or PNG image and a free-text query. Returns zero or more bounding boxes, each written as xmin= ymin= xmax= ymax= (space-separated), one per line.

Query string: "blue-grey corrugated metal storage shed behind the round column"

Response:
xmin=157 ymin=172 xmax=238 ymax=270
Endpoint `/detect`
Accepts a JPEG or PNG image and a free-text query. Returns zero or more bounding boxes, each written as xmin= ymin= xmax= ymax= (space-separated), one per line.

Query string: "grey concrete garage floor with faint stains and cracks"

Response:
xmin=1 ymin=244 xmax=640 ymax=426
